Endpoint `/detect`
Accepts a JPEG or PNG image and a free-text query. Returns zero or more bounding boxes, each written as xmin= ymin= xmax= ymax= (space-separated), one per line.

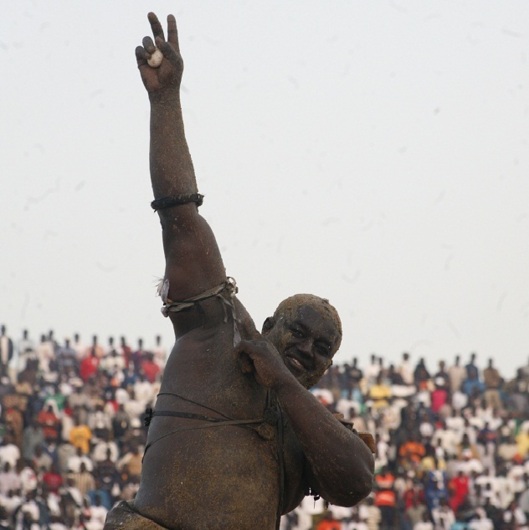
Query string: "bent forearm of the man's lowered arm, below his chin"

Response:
xmin=275 ymin=378 xmax=374 ymax=506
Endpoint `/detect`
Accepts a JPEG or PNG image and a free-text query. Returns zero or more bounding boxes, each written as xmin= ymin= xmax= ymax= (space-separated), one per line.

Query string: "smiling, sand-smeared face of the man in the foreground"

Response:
xmin=264 ymin=305 xmax=341 ymax=388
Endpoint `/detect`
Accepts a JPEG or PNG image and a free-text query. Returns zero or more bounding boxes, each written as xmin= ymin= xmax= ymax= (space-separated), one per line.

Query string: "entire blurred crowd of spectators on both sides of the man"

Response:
xmin=0 ymin=326 xmax=529 ymax=530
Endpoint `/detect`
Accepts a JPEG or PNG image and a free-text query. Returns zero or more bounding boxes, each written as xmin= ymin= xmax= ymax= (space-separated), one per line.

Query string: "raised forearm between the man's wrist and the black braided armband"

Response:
xmin=149 ymin=89 xmax=197 ymax=199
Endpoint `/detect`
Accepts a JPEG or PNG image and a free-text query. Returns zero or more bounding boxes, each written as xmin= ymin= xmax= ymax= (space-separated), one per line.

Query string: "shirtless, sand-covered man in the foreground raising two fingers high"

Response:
xmin=105 ymin=13 xmax=373 ymax=530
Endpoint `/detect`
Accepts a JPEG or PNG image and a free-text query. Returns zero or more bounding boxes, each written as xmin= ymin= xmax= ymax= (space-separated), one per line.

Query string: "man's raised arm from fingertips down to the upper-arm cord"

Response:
xmin=136 ymin=13 xmax=226 ymax=308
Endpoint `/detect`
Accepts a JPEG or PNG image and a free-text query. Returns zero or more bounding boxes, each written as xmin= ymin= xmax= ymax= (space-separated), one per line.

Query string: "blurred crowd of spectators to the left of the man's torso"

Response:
xmin=0 ymin=326 xmax=166 ymax=530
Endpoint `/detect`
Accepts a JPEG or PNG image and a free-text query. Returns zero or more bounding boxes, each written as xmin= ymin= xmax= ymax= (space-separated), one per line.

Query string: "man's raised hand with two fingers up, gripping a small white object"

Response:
xmin=136 ymin=13 xmax=184 ymax=95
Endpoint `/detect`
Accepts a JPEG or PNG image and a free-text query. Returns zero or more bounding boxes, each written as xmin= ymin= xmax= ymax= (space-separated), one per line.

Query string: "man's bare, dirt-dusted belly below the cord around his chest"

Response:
xmin=135 ymin=418 xmax=279 ymax=530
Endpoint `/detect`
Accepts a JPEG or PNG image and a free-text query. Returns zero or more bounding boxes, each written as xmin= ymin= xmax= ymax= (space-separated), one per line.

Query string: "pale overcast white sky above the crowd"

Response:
xmin=0 ymin=0 xmax=529 ymax=376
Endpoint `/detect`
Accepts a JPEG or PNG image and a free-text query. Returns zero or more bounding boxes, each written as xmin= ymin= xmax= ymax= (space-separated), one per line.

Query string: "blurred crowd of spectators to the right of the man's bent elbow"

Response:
xmin=283 ymin=353 xmax=529 ymax=530
